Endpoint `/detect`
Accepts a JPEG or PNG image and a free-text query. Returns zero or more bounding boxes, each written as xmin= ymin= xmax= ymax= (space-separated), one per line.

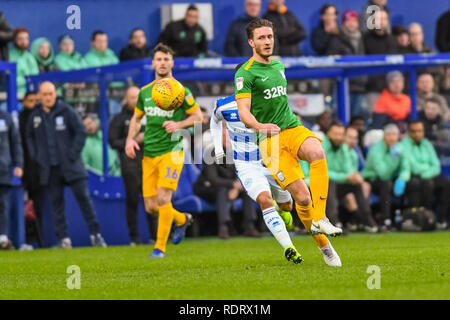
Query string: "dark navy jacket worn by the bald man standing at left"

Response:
xmin=26 ymin=99 xmax=87 ymax=185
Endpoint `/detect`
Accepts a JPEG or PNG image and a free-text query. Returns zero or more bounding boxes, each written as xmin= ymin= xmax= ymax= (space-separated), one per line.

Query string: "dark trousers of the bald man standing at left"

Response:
xmin=47 ymin=166 xmax=100 ymax=239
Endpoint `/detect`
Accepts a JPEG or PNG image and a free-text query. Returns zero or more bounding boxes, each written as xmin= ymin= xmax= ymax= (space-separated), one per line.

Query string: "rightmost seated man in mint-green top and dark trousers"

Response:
xmin=401 ymin=120 xmax=450 ymax=229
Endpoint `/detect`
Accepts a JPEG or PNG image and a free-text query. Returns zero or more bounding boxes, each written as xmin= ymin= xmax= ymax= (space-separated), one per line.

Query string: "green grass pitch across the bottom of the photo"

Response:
xmin=0 ymin=232 xmax=450 ymax=300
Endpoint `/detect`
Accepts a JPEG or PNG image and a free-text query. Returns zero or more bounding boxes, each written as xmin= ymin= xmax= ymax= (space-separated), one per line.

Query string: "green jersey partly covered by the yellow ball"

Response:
xmin=135 ymin=81 xmax=198 ymax=157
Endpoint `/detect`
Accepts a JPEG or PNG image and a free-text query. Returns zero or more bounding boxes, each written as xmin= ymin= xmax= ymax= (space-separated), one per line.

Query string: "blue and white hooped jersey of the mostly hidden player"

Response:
xmin=212 ymin=94 xmax=261 ymax=162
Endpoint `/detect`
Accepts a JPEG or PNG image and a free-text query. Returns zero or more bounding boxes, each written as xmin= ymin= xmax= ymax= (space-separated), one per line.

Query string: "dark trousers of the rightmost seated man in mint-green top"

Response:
xmin=406 ymin=175 xmax=450 ymax=222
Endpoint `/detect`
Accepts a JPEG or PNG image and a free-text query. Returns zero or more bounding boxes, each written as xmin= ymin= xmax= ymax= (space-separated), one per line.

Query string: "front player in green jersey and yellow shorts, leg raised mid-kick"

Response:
xmin=235 ymin=19 xmax=342 ymax=266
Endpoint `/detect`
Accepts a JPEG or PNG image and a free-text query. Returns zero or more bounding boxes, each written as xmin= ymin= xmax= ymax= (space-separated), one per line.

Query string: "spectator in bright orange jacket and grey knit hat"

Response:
xmin=372 ymin=71 xmax=411 ymax=132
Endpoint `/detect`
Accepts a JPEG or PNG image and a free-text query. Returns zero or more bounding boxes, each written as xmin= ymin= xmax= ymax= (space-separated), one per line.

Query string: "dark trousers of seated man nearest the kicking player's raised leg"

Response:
xmin=327 ymin=180 xmax=375 ymax=226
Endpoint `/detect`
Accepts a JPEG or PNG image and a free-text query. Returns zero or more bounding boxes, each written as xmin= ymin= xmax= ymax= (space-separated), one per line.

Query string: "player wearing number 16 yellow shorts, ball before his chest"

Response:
xmin=125 ymin=44 xmax=202 ymax=258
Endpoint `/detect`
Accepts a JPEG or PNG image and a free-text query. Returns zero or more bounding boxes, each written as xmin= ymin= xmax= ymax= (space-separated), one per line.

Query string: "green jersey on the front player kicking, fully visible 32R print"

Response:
xmin=234 ymin=59 xmax=301 ymax=136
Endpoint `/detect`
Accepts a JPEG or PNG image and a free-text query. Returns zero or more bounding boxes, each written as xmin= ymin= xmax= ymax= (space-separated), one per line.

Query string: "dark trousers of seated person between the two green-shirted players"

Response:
xmin=195 ymin=187 xmax=257 ymax=229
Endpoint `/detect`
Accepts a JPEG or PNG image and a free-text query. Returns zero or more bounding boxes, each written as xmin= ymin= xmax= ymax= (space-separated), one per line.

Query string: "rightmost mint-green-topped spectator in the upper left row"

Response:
xmin=84 ymin=30 xmax=119 ymax=68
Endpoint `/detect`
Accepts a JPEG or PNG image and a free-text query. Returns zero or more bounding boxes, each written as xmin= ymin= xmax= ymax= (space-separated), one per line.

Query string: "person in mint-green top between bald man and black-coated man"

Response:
xmin=81 ymin=115 xmax=120 ymax=177
